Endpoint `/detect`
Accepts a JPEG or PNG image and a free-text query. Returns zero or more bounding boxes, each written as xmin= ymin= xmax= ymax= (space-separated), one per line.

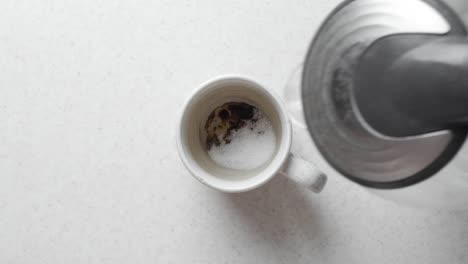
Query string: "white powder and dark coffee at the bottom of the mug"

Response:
xmin=205 ymin=102 xmax=276 ymax=170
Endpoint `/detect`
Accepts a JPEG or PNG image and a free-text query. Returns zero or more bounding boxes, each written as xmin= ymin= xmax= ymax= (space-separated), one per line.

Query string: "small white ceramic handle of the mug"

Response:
xmin=280 ymin=154 xmax=327 ymax=193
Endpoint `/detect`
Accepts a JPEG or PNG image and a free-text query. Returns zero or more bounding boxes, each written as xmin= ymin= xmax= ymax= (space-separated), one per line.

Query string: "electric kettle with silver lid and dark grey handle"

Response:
xmin=301 ymin=0 xmax=468 ymax=209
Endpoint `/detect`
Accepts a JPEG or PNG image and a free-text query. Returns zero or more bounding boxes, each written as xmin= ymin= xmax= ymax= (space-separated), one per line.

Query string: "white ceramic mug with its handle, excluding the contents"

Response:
xmin=177 ymin=76 xmax=327 ymax=193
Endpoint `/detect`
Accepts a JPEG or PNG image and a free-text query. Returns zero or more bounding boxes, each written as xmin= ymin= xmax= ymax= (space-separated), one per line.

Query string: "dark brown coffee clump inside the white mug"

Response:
xmin=205 ymin=102 xmax=258 ymax=150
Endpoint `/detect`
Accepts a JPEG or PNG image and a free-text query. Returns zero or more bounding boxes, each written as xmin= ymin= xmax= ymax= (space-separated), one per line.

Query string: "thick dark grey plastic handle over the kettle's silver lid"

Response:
xmin=354 ymin=34 xmax=468 ymax=137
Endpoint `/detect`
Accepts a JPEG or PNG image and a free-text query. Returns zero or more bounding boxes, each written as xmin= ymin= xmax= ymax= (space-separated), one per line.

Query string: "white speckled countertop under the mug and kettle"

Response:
xmin=0 ymin=0 xmax=468 ymax=264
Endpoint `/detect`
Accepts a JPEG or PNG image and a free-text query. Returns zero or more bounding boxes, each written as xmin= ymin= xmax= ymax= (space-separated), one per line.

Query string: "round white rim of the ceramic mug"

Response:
xmin=176 ymin=74 xmax=292 ymax=193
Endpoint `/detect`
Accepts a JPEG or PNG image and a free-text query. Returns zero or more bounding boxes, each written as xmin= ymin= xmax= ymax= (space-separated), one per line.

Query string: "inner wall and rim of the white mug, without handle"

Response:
xmin=181 ymin=79 xmax=290 ymax=191
